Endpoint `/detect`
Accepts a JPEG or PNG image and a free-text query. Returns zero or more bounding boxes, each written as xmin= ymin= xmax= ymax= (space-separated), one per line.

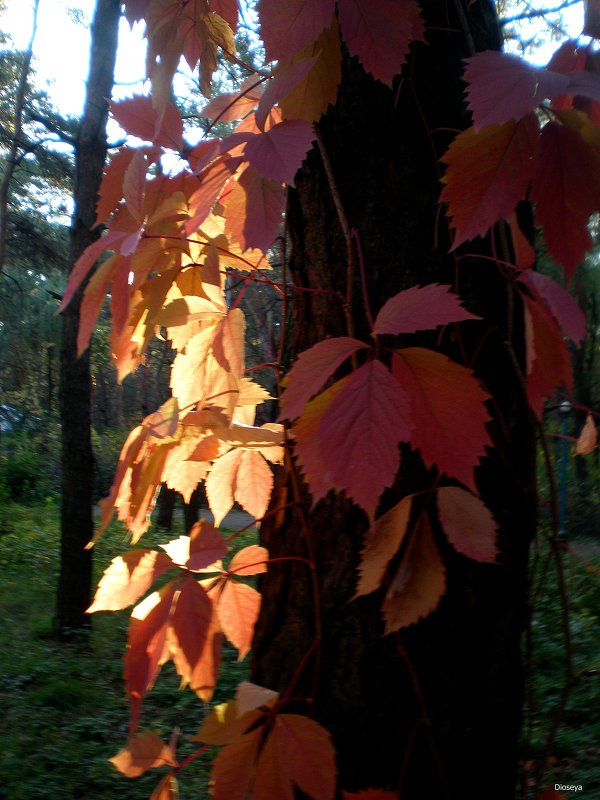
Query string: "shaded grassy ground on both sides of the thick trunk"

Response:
xmin=0 ymin=504 xmax=600 ymax=800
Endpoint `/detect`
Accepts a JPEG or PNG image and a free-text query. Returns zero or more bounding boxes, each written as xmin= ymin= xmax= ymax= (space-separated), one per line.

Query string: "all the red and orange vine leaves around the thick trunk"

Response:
xmin=63 ymin=0 xmax=600 ymax=800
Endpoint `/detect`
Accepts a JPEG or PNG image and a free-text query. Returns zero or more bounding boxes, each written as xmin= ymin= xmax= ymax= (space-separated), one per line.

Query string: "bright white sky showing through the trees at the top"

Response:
xmin=0 ymin=0 xmax=583 ymax=125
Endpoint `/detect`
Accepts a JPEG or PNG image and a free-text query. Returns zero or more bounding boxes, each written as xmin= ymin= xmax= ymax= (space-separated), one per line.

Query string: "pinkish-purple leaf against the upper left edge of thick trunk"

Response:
xmin=244 ymin=119 xmax=315 ymax=186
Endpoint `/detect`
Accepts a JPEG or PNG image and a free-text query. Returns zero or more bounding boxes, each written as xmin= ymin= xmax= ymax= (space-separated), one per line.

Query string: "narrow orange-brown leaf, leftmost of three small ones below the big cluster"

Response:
xmin=356 ymin=495 xmax=413 ymax=597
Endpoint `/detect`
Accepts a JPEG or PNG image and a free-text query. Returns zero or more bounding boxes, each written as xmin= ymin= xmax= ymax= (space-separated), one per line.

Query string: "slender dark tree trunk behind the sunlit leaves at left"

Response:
xmin=54 ymin=0 xmax=121 ymax=639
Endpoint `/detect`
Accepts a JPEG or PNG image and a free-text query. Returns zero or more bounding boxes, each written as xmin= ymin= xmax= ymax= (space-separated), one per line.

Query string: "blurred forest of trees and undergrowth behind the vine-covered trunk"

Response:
xmin=0 ymin=0 xmax=600 ymax=798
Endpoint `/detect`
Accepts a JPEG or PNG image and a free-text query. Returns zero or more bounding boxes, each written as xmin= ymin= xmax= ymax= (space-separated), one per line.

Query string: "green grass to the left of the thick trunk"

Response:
xmin=0 ymin=504 xmax=256 ymax=800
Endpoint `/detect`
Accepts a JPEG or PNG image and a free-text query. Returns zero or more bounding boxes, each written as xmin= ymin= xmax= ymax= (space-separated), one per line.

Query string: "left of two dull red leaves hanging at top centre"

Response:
xmin=258 ymin=0 xmax=335 ymax=61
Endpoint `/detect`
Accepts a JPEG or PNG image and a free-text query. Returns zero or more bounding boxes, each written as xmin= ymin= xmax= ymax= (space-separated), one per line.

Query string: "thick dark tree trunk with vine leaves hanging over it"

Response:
xmin=253 ymin=0 xmax=535 ymax=800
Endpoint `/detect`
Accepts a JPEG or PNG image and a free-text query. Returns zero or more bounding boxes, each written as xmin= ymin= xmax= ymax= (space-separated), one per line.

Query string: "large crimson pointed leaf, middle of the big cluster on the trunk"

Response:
xmin=317 ymin=360 xmax=410 ymax=517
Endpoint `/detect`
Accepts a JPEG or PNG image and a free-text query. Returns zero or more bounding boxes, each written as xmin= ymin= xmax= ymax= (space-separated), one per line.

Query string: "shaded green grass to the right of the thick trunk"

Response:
xmin=522 ymin=537 xmax=600 ymax=798
